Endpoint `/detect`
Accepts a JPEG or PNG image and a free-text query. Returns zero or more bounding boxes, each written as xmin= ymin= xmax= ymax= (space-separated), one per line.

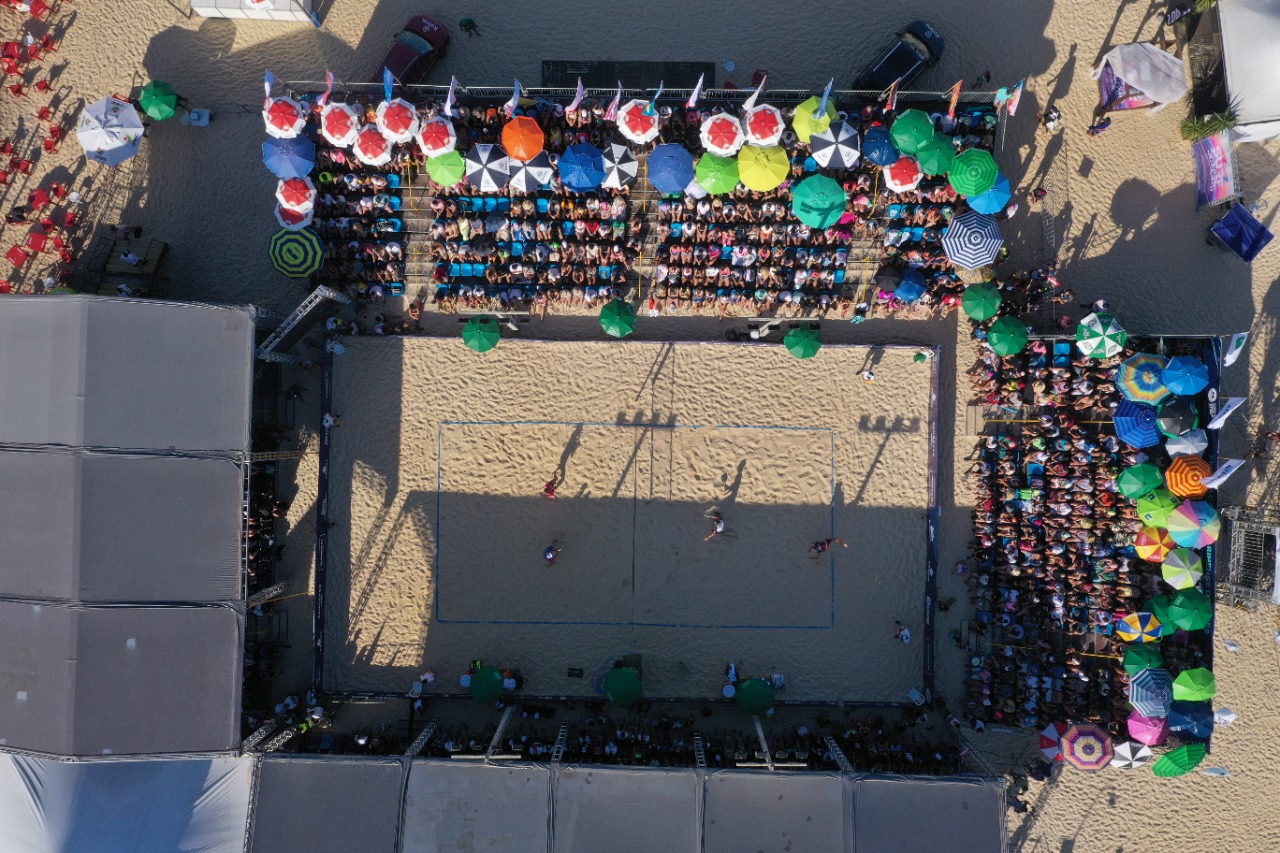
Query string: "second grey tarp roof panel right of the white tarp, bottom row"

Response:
xmin=401 ymin=760 xmax=552 ymax=853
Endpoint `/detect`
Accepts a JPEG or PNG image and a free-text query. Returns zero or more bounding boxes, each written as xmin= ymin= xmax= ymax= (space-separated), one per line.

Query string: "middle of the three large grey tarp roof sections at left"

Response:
xmin=0 ymin=451 xmax=244 ymax=602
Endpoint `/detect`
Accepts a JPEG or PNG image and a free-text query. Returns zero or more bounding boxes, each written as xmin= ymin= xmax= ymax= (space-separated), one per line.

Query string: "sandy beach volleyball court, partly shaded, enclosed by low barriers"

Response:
xmin=325 ymin=338 xmax=933 ymax=702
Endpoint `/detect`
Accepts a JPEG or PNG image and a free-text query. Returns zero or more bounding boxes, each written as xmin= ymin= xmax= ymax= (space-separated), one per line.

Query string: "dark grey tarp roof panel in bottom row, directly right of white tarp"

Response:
xmin=248 ymin=756 xmax=406 ymax=853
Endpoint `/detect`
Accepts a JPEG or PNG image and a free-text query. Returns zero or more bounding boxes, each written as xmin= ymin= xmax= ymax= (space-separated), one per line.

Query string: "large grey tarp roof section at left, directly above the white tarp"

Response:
xmin=0 ymin=601 xmax=244 ymax=756
